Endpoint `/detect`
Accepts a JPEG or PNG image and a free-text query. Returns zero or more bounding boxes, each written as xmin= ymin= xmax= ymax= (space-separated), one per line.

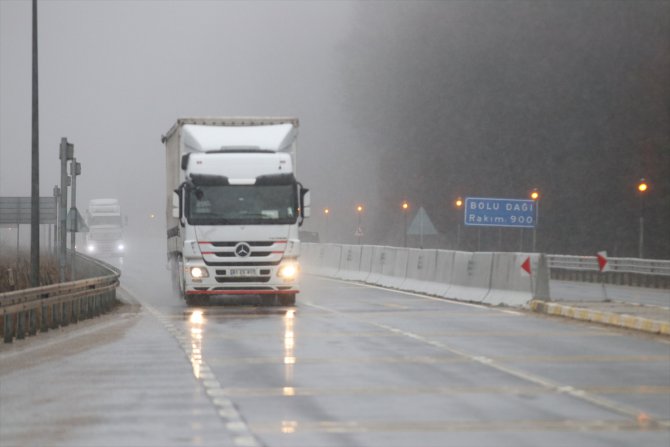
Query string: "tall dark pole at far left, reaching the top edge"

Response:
xmin=30 ymin=0 xmax=40 ymax=287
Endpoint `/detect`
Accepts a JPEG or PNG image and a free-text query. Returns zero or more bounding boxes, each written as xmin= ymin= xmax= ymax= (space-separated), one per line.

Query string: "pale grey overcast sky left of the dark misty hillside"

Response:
xmin=0 ymin=0 xmax=360 ymax=242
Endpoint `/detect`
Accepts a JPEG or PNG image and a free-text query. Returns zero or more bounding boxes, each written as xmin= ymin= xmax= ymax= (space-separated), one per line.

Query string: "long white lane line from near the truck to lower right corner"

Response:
xmin=302 ymin=301 xmax=670 ymax=427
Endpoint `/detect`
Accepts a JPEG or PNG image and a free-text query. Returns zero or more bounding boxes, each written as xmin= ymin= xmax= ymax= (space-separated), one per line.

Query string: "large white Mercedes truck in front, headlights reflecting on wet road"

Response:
xmin=162 ymin=118 xmax=310 ymax=305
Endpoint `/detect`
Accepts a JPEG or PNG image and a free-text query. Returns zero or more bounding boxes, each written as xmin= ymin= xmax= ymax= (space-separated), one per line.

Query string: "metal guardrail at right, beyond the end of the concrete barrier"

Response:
xmin=547 ymin=255 xmax=670 ymax=288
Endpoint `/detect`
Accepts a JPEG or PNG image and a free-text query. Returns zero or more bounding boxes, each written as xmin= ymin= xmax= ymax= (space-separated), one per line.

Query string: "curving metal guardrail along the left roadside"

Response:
xmin=0 ymin=253 xmax=121 ymax=343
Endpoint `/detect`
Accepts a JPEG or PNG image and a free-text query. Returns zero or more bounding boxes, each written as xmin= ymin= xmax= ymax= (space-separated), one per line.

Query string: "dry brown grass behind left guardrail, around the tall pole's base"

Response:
xmin=0 ymin=253 xmax=58 ymax=293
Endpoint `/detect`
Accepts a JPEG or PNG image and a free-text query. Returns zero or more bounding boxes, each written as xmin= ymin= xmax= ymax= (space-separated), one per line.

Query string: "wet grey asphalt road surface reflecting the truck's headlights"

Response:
xmin=0 ymin=248 xmax=670 ymax=447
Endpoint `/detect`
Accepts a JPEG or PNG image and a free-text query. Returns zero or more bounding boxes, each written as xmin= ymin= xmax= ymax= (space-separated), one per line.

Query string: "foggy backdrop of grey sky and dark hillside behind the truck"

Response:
xmin=0 ymin=0 xmax=670 ymax=258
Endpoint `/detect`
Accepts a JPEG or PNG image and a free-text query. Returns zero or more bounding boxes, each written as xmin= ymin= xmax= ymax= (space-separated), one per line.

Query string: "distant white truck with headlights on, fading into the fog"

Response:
xmin=86 ymin=199 xmax=126 ymax=257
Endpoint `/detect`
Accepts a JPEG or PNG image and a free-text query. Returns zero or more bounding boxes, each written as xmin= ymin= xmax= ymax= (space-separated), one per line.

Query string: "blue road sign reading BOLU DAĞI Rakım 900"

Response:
xmin=464 ymin=197 xmax=538 ymax=228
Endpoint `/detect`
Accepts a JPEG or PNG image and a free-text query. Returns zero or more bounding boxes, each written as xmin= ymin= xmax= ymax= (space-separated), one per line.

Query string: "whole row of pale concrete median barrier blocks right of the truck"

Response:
xmin=303 ymin=243 xmax=549 ymax=307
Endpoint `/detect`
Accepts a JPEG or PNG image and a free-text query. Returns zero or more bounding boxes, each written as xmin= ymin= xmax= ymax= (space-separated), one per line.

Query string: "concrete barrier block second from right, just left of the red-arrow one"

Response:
xmin=441 ymin=251 xmax=493 ymax=302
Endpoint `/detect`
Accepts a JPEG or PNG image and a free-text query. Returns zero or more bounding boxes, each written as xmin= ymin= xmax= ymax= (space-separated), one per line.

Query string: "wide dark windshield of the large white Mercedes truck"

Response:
xmin=186 ymin=185 xmax=298 ymax=225
